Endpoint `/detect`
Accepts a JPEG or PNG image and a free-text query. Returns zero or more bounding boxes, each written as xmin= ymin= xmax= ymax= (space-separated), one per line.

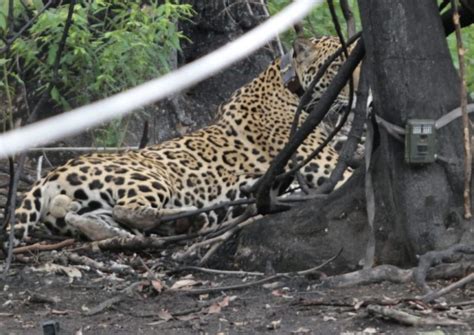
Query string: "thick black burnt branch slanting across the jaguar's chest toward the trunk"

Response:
xmin=256 ymin=39 xmax=365 ymax=214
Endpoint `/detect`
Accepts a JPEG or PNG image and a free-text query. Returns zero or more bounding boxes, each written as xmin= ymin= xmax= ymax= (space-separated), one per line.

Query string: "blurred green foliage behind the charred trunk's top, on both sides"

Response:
xmin=268 ymin=0 xmax=474 ymax=98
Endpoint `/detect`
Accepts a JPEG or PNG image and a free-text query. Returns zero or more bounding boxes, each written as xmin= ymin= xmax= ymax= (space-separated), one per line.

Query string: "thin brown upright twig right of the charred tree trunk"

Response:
xmin=451 ymin=0 xmax=472 ymax=220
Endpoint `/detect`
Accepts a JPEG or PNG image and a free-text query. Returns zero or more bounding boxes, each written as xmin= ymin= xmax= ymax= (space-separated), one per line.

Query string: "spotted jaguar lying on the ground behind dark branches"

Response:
xmin=13 ymin=37 xmax=356 ymax=239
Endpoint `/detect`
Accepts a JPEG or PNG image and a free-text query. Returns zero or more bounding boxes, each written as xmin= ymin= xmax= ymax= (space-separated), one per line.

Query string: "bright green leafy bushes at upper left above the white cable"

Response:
xmin=0 ymin=0 xmax=193 ymax=144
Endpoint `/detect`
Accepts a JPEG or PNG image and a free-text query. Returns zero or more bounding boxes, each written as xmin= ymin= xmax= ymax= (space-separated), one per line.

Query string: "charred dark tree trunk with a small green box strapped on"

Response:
xmin=359 ymin=0 xmax=465 ymax=260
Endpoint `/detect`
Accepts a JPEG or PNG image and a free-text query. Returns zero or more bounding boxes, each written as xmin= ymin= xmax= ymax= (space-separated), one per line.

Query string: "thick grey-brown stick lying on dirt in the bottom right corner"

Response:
xmin=367 ymin=305 xmax=467 ymax=327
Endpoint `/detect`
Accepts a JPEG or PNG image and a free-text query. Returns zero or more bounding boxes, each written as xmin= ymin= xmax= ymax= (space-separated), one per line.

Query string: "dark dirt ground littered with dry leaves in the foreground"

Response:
xmin=0 ymin=243 xmax=474 ymax=335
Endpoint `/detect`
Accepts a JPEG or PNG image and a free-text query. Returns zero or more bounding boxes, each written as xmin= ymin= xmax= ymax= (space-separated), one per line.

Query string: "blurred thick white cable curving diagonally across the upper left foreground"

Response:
xmin=0 ymin=0 xmax=324 ymax=158
